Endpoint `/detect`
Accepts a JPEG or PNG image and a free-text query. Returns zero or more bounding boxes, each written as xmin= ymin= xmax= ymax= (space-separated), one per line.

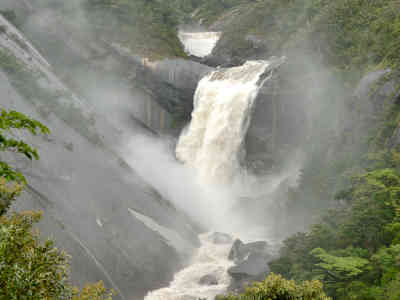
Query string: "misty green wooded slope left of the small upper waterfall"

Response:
xmin=0 ymin=0 xmax=185 ymax=59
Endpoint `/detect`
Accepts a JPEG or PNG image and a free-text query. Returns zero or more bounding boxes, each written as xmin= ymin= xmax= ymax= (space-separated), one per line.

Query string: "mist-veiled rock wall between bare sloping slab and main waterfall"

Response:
xmin=0 ymin=1 xmax=211 ymax=134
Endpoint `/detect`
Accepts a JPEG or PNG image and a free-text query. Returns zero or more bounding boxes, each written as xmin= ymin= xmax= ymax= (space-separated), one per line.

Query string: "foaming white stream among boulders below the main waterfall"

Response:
xmin=144 ymin=234 xmax=233 ymax=300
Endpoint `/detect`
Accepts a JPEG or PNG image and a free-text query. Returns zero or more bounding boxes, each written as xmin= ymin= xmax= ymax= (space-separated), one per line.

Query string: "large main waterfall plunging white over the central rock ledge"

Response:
xmin=176 ymin=61 xmax=270 ymax=184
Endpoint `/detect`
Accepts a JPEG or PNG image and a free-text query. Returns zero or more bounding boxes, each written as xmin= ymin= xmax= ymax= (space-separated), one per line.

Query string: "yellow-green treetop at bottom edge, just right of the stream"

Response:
xmin=217 ymin=273 xmax=330 ymax=300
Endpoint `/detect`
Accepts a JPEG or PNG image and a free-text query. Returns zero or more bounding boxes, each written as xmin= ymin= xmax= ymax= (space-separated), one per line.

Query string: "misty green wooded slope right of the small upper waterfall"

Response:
xmin=196 ymin=0 xmax=400 ymax=74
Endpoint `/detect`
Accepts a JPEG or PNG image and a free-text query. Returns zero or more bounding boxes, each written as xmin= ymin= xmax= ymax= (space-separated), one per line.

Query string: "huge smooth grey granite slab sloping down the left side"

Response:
xmin=0 ymin=12 xmax=202 ymax=299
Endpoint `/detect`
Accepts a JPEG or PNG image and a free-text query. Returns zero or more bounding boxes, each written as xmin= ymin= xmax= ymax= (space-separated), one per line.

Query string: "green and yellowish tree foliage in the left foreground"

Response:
xmin=0 ymin=109 xmax=112 ymax=300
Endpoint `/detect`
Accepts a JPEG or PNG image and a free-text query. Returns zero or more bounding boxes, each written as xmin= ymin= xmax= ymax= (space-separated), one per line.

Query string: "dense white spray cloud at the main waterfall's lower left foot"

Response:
xmin=122 ymin=135 xmax=236 ymax=231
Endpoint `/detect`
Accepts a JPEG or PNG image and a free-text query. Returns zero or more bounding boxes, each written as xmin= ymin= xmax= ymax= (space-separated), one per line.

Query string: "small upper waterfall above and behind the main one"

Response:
xmin=179 ymin=31 xmax=221 ymax=57
